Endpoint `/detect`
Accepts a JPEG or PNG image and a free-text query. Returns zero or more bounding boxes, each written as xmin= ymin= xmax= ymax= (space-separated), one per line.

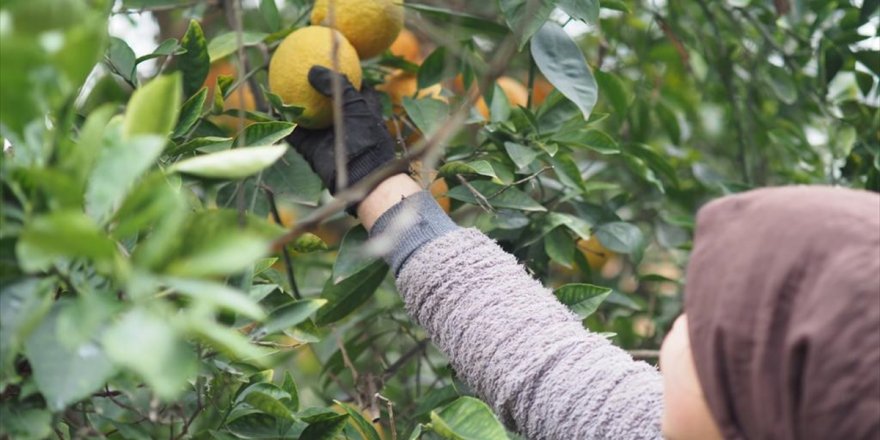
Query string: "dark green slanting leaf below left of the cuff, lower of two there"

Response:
xmin=315 ymin=260 xmax=388 ymax=325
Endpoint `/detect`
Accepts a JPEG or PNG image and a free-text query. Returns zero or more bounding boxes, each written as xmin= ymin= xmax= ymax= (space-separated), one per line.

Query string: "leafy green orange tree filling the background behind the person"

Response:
xmin=0 ymin=0 xmax=880 ymax=439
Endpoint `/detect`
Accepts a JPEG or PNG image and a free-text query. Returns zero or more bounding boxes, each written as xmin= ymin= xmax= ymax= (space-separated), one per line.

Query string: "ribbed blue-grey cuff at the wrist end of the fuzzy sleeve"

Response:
xmin=370 ymin=191 xmax=459 ymax=276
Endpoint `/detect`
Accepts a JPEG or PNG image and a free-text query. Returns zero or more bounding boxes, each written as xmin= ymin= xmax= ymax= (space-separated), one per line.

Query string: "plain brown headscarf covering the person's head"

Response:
xmin=685 ymin=187 xmax=880 ymax=440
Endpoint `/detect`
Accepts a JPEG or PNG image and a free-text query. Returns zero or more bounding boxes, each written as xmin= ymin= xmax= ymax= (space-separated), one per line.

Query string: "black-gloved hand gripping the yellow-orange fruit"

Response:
xmin=287 ymin=66 xmax=394 ymax=198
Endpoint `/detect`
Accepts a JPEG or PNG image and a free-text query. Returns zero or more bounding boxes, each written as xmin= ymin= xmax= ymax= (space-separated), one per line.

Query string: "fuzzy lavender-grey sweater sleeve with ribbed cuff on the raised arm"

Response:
xmin=371 ymin=191 xmax=663 ymax=439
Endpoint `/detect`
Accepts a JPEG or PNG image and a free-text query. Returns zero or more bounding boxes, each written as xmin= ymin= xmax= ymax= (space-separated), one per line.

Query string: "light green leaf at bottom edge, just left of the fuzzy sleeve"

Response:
xmin=431 ymin=397 xmax=508 ymax=440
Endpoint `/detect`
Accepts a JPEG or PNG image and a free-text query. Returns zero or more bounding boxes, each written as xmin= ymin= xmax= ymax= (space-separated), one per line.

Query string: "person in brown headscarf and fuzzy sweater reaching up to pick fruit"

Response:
xmin=289 ymin=67 xmax=880 ymax=440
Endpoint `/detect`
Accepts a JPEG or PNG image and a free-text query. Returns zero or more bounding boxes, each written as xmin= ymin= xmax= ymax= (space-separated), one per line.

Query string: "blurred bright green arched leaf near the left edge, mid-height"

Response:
xmin=15 ymin=211 xmax=116 ymax=272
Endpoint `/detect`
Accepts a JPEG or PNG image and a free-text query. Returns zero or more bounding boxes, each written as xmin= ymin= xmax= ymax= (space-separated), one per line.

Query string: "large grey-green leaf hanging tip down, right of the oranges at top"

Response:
xmin=531 ymin=21 xmax=598 ymax=120
